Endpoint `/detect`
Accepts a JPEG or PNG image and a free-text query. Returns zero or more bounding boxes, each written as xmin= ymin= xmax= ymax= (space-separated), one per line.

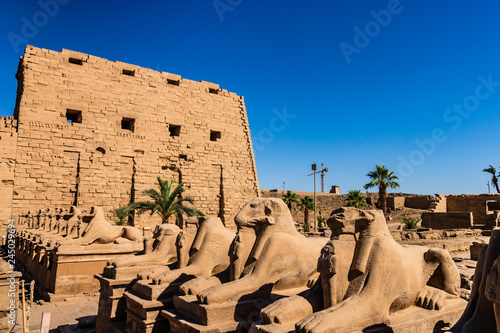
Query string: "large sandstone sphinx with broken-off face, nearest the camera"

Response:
xmin=256 ymin=208 xmax=466 ymax=333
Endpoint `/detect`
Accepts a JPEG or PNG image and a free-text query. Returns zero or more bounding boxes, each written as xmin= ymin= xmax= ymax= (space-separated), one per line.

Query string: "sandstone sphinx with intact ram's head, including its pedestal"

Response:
xmin=163 ymin=198 xmax=327 ymax=332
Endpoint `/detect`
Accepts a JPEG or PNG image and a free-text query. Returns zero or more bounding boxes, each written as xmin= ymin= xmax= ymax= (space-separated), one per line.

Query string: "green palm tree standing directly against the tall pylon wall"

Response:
xmin=131 ymin=177 xmax=204 ymax=227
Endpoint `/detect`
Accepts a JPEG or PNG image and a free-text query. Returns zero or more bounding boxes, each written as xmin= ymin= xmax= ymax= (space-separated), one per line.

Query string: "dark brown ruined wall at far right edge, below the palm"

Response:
xmin=446 ymin=194 xmax=500 ymax=225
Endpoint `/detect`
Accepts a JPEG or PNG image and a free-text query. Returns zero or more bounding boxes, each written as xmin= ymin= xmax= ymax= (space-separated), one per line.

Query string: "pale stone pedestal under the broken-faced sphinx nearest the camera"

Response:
xmin=250 ymin=298 xmax=467 ymax=333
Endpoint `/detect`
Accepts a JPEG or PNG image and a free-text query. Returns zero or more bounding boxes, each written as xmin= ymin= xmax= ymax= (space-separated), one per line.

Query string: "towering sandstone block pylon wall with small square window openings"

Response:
xmin=0 ymin=46 xmax=259 ymax=227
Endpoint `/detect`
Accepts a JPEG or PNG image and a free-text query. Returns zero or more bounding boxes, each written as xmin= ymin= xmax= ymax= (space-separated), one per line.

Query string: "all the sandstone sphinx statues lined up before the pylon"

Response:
xmin=13 ymin=198 xmax=500 ymax=333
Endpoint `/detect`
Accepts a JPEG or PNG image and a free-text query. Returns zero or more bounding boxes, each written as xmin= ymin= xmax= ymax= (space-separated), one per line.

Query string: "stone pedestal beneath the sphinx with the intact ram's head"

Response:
xmin=161 ymin=288 xmax=304 ymax=333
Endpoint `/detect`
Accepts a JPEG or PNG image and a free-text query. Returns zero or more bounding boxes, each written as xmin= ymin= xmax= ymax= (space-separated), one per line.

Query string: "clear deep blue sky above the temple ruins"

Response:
xmin=0 ymin=0 xmax=500 ymax=194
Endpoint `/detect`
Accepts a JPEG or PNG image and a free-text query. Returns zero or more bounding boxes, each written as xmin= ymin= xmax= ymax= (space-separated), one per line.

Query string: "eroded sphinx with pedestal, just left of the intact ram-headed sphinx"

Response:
xmin=124 ymin=216 xmax=235 ymax=333
